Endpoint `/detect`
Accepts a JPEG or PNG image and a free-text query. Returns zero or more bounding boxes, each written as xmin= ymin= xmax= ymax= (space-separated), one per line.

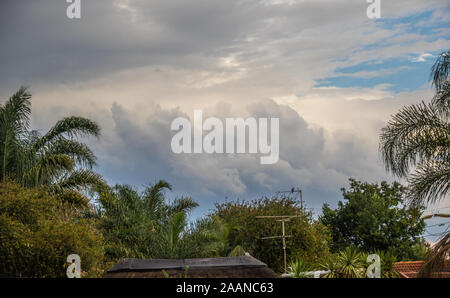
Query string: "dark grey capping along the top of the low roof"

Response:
xmin=108 ymin=256 xmax=267 ymax=272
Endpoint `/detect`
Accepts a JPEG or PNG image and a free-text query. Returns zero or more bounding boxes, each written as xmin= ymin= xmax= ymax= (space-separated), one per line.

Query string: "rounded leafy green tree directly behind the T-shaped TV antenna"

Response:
xmin=210 ymin=197 xmax=330 ymax=272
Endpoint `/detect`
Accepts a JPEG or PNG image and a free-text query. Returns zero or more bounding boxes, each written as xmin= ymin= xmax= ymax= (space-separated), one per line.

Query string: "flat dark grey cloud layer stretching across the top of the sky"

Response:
xmin=0 ymin=0 xmax=445 ymax=91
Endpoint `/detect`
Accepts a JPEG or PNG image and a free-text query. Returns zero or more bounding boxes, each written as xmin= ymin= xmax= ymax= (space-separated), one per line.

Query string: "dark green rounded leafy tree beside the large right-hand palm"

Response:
xmin=320 ymin=179 xmax=425 ymax=259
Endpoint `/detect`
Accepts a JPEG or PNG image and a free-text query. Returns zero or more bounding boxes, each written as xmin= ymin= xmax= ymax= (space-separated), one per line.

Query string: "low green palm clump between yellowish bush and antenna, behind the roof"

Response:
xmin=97 ymin=180 xmax=207 ymax=260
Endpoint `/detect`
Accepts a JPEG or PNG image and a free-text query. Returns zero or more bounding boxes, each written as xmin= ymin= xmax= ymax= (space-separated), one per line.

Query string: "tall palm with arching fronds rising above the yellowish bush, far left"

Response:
xmin=0 ymin=87 xmax=106 ymax=207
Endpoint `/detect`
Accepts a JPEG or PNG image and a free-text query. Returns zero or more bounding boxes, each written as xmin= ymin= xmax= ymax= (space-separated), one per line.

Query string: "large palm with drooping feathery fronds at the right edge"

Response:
xmin=380 ymin=51 xmax=450 ymax=278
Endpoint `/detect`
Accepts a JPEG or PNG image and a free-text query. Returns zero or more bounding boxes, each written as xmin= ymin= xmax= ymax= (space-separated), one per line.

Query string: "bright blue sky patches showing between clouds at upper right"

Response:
xmin=316 ymin=7 xmax=450 ymax=93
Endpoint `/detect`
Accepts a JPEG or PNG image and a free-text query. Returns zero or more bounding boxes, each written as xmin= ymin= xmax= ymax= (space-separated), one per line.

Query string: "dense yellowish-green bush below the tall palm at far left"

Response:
xmin=0 ymin=183 xmax=103 ymax=277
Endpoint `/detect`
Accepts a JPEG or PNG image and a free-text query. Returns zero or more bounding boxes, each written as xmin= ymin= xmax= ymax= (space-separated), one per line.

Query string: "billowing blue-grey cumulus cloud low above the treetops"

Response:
xmin=78 ymin=100 xmax=376 ymax=217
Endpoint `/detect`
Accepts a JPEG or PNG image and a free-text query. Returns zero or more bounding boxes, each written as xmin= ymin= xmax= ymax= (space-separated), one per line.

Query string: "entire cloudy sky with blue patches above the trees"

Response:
xmin=0 ymin=0 xmax=450 ymax=240
